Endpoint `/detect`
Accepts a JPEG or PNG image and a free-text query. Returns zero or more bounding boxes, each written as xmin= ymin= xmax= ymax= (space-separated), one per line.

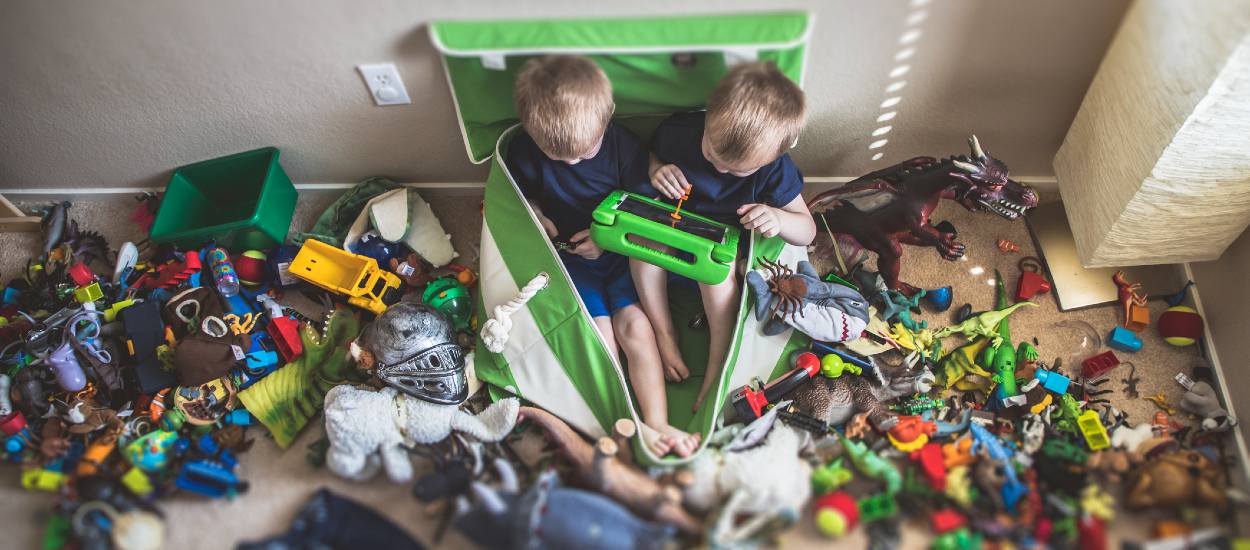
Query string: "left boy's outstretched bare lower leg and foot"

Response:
xmin=611 ymin=305 xmax=699 ymax=458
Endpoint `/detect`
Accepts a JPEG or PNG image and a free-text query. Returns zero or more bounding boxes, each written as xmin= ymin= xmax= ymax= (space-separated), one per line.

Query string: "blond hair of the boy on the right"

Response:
xmin=704 ymin=61 xmax=806 ymax=163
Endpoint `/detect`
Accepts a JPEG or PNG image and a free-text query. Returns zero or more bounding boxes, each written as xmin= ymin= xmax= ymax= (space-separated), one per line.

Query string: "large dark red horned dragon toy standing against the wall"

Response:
xmin=808 ymin=135 xmax=1038 ymax=296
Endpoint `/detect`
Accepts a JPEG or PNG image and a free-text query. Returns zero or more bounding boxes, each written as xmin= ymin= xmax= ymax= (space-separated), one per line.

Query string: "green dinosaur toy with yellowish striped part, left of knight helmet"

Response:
xmin=239 ymin=309 xmax=369 ymax=449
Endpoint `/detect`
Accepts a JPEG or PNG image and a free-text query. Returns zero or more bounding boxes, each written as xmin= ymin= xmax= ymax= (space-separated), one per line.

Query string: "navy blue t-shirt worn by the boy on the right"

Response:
xmin=626 ymin=111 xmax=803 ymax=228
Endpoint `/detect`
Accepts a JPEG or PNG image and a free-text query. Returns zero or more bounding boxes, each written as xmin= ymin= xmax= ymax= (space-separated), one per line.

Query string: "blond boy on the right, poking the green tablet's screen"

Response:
xmin=628 ymin=63 xmax=816 ymax=410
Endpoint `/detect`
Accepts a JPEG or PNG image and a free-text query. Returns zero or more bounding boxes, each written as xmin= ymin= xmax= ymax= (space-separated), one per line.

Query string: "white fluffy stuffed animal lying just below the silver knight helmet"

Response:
xmin=325 ymin=385 xmax=520 ymax=483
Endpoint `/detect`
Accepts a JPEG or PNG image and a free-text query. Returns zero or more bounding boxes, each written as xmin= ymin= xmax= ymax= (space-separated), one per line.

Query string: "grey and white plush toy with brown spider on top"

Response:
xmin=746 ymin=260 xmax=869 ymax=341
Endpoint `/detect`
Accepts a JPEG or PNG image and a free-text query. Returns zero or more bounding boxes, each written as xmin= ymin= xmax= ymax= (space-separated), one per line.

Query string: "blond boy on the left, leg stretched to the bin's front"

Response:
xmin=505 ymin=55 xmax=699 ymax=456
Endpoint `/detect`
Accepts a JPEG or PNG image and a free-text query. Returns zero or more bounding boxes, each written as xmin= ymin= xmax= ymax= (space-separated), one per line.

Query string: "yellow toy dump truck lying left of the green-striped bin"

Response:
xmin=290 ymin=239 xmax=403 ymax=314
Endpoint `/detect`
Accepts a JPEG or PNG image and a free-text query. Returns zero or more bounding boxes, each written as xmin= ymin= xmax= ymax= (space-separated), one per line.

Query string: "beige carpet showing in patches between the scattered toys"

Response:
xmin=0 ymin=187 xmax=1230 ymax=548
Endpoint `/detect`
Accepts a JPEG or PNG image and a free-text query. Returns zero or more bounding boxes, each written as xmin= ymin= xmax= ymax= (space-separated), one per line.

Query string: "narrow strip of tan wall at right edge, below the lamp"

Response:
xmin=1190 ymin=231 xmax=1250 ymax=439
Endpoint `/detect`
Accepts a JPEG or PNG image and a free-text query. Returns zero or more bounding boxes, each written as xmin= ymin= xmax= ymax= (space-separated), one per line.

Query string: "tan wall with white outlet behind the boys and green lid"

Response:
xmin=0 ymin=0 xmax=1126 ymax=188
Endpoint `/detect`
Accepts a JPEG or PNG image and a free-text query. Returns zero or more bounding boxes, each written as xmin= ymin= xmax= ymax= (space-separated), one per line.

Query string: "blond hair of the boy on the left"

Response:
xmin=513 ymin=55 xmax=615 ymax=159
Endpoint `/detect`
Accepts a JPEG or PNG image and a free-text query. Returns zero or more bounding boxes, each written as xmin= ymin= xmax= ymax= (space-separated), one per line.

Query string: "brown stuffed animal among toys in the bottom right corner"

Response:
xmin=1125 ymin=450 xmax=1228 ymax=509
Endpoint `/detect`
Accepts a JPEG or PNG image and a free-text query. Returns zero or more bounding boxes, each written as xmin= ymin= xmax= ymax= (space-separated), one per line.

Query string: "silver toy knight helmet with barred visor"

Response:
xmin=359 ymin=301 xmax=469 ymax=405
